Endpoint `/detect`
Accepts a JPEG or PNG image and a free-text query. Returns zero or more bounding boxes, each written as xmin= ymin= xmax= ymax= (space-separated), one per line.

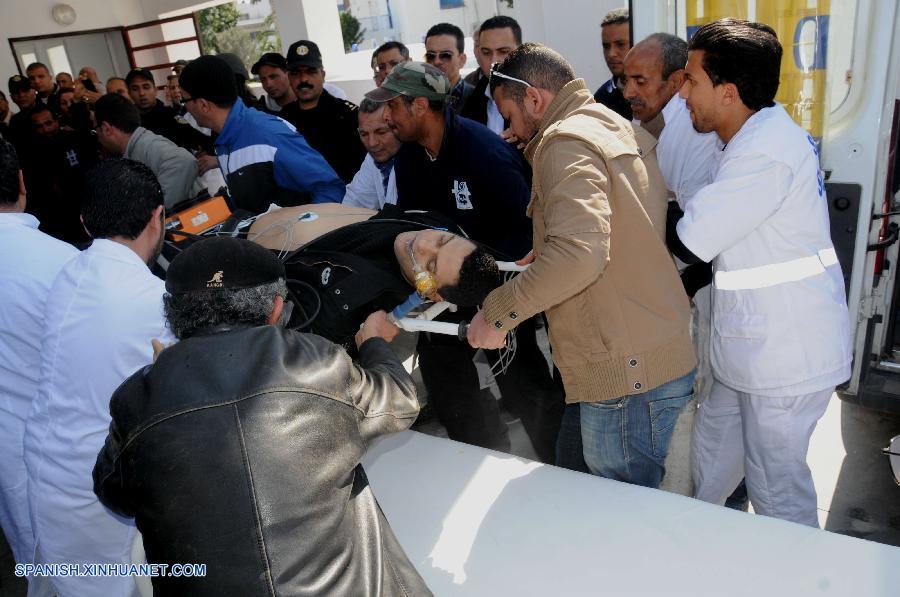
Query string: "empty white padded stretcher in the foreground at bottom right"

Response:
xmin=363 ymin=431 xmax=900 ymax=597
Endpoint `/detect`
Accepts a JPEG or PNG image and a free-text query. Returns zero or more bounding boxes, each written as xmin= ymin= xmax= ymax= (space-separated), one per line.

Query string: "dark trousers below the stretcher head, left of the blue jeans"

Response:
xmin=417 ymin=314 xmax=565 ymax=464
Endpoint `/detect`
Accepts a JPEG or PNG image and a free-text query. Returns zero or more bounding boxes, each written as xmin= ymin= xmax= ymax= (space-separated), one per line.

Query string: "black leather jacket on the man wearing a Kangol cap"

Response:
xmin=94 ymin=326 xmax=431 ymax=597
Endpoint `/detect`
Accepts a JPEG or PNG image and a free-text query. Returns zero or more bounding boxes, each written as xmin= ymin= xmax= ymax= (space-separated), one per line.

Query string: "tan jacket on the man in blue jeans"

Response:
xmin=484 ymin=79 xmax=696 ymax=402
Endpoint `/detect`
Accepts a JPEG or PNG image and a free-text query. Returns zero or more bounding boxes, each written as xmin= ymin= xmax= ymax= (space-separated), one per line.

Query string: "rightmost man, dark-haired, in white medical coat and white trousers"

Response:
xmin=677 ymin=19 xmax=851 ymax=526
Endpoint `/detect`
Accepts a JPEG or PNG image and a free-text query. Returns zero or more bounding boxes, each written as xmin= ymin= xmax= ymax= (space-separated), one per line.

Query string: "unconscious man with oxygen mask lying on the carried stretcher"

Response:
xmin=247 ymin=203 xmax=501 ymax=343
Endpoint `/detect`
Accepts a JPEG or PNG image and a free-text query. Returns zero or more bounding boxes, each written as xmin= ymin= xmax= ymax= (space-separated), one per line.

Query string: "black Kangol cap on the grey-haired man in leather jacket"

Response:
xmin=166 ymin=237 xmax=285 ymax=294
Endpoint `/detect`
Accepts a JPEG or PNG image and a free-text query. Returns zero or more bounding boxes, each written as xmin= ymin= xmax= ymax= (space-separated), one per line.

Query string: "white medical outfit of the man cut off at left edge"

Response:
xmin=0 ymin=213 xmax=78 ymax=563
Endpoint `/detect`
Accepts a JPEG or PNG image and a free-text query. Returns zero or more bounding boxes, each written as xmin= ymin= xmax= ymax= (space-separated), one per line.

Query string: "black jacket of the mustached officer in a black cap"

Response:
xmin=276 ymin=89 xmax=366 ymax=184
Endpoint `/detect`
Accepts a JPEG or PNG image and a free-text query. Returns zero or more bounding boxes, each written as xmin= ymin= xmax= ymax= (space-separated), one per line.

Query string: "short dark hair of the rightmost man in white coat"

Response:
xmin=688 ymin=19 xmax=782 ymax=110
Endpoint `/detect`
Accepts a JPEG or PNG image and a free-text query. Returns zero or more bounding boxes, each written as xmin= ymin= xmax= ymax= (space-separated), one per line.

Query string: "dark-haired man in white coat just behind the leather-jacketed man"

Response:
xmin=24 ymin=159 xmax=170 ymax=597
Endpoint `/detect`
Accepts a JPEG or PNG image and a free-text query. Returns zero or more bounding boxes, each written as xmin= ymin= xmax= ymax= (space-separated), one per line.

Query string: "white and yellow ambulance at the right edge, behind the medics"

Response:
xmin=630 ymin=0 xmax=900 ymax=412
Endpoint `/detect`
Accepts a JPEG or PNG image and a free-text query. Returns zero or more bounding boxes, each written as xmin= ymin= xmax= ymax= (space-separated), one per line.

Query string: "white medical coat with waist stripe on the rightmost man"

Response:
xmin=677 ymin=104 xmax=851 ymax=396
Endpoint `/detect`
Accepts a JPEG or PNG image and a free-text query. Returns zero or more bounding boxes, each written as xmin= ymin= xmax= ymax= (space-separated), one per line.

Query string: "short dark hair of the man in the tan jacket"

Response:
xmin=491 ymin=42 xmax=575 ymax=104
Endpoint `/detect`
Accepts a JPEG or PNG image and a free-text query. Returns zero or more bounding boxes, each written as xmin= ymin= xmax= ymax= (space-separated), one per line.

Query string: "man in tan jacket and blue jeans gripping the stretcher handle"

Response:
xmin=469 ymin=43 xmax=696 ymax=487
